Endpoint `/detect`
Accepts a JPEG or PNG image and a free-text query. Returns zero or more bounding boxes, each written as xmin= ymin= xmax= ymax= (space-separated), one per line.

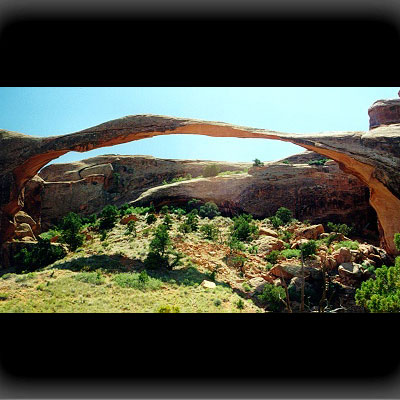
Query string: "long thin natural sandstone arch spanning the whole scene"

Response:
xmin=0 ymin=110 xmax=400 ymax=254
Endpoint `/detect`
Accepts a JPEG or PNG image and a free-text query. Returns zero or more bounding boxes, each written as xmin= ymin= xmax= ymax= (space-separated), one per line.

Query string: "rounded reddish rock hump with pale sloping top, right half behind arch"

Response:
xmin=132 ymin=152 xmax=376 ymax=236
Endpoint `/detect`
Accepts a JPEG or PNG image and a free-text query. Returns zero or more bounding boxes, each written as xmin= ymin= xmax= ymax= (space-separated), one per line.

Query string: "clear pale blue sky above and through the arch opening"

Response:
xmin=0 ymin=87 xmax=399 ymax=162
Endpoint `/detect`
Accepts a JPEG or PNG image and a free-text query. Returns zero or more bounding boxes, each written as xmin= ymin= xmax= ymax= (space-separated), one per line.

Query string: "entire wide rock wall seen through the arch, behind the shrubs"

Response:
xmin=24 ymin=151 xmax=376 ymax=236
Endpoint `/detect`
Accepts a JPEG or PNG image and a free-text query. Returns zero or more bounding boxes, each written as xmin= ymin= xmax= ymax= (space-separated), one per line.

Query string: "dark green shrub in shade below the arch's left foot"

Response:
xmin=14 ymin=237 xmax=66 ymax=271
